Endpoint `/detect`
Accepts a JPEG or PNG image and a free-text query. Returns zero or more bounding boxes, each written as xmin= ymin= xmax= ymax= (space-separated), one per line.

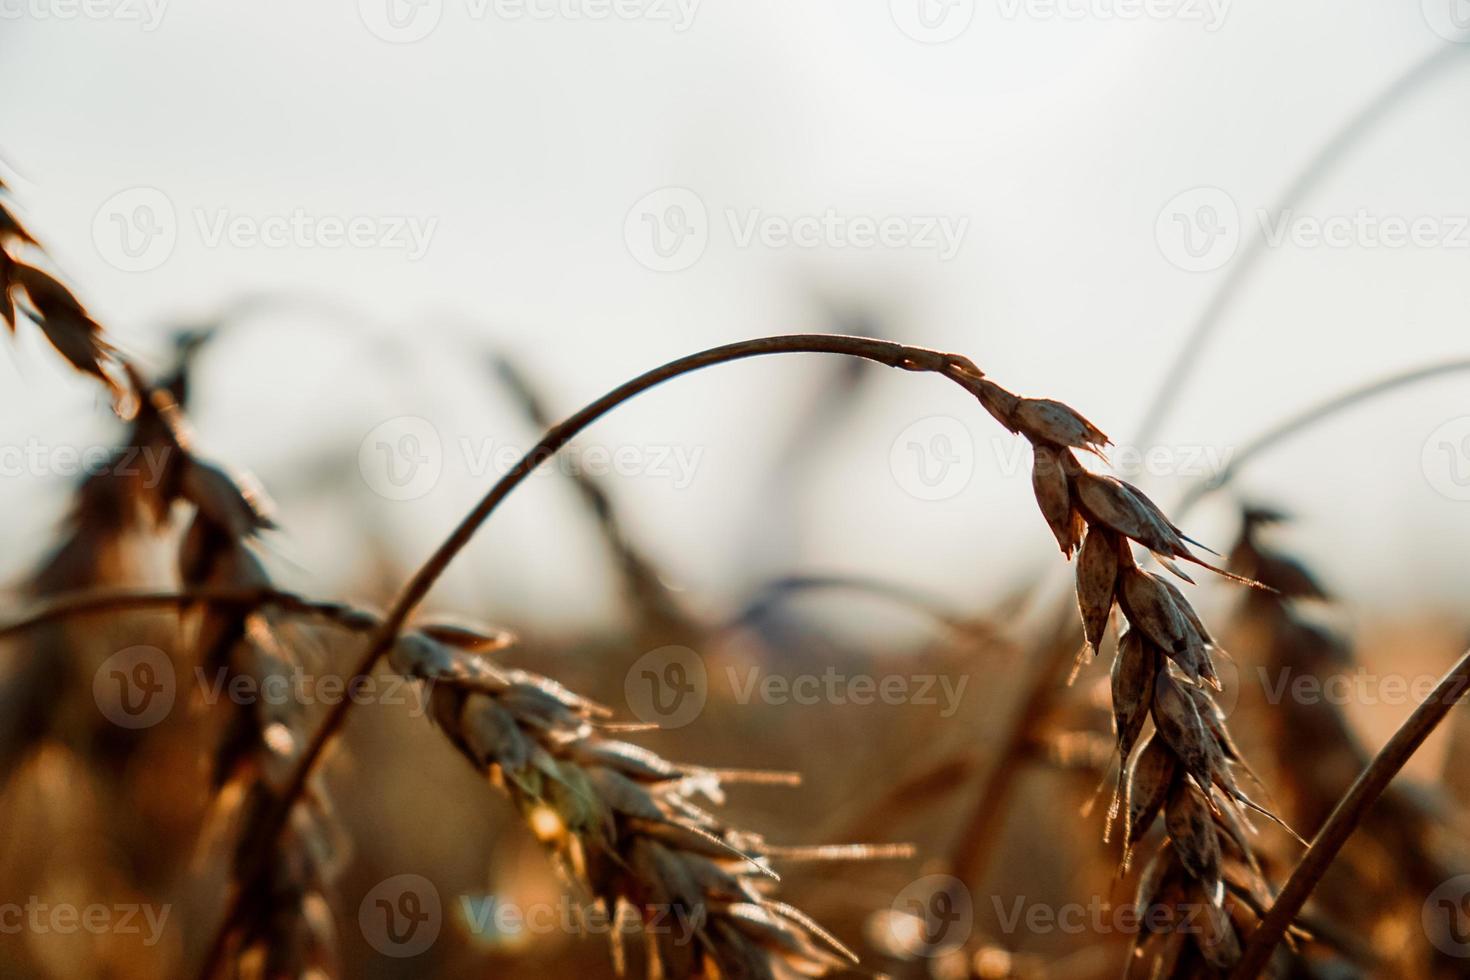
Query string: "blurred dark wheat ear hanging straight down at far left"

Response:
xmin=125 ymin=366 xmax=340 ymax=977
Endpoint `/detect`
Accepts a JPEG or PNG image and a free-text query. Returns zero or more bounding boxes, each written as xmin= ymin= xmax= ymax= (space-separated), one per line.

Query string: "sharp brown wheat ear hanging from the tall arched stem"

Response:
xmin=966 ymin=378 xmax=1287 ymax=977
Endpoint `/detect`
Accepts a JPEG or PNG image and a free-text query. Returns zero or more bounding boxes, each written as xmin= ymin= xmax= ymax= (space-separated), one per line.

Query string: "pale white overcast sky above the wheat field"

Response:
xmin=0 ymin=0 xmax=1470 ymax=637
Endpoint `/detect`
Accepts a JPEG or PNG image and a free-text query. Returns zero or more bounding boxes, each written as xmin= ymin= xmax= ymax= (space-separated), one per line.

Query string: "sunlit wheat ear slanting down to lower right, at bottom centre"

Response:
xmin=390 ymin=629 xmax=869 ymax=977
